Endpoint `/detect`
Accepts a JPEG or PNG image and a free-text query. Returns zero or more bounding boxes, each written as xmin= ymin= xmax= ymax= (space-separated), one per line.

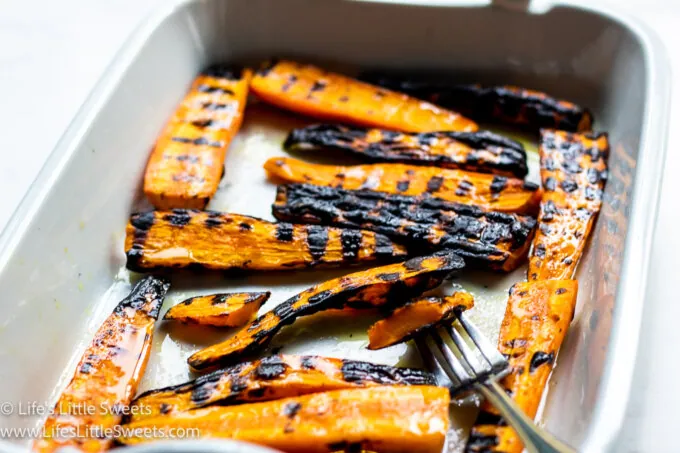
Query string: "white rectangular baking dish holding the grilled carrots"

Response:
xmin=0 ymin=0 xmax=669 ymax=452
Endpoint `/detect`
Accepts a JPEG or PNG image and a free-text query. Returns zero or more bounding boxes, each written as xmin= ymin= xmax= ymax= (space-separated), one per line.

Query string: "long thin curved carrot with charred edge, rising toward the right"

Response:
xmin=189 ymin=251 xmax=464 ymax=370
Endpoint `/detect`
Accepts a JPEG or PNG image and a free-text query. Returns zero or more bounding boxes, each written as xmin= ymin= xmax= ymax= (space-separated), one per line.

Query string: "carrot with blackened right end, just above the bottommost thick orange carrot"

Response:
xmin=130 ymin=355 xmax=435 ymax=422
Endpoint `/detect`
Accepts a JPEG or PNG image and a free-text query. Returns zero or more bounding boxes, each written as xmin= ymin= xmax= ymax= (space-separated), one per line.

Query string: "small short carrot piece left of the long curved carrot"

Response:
xmin=163 ymin=291 xmax=271 ymax=327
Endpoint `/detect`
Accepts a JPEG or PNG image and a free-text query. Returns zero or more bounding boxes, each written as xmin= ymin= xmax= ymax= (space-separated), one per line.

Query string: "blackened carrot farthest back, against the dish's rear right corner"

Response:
xmin=362 ymin=74 xmax=593 ymax=132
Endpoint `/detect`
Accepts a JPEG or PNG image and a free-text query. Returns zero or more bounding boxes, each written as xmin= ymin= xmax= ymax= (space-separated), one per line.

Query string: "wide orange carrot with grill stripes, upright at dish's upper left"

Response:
xmin=144 ymin=66 xmax=252 ymax=209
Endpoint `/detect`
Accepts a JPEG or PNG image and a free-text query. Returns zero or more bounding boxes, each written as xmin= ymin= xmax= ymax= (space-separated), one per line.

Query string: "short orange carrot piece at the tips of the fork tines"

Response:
xmin=368 ymin=292 xmax=474 ymax=349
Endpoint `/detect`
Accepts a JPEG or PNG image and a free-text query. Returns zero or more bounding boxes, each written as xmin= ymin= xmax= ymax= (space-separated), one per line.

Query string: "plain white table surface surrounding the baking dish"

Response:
xmin=0 ymin=0 xmax=680 ymax=453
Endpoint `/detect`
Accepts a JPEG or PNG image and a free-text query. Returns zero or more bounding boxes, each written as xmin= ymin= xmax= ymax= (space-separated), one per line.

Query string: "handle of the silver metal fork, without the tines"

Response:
xmin=476 ymin=380 xmax=576 ymax=453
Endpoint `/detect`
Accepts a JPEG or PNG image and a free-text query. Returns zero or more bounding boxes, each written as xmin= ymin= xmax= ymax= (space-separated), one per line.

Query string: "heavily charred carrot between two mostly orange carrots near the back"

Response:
xmin=283 ymin=124 xmax=528 ymax=178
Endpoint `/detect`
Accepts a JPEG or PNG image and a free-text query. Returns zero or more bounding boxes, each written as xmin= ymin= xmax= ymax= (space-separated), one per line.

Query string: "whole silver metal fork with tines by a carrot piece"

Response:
xmin=416 ymin=313 xmax=575 ymax=453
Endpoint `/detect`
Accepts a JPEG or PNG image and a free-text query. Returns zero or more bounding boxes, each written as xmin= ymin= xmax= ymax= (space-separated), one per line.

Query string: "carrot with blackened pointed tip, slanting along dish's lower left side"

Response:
xmin=33 ymin=277 xmax=170 ymax=453
